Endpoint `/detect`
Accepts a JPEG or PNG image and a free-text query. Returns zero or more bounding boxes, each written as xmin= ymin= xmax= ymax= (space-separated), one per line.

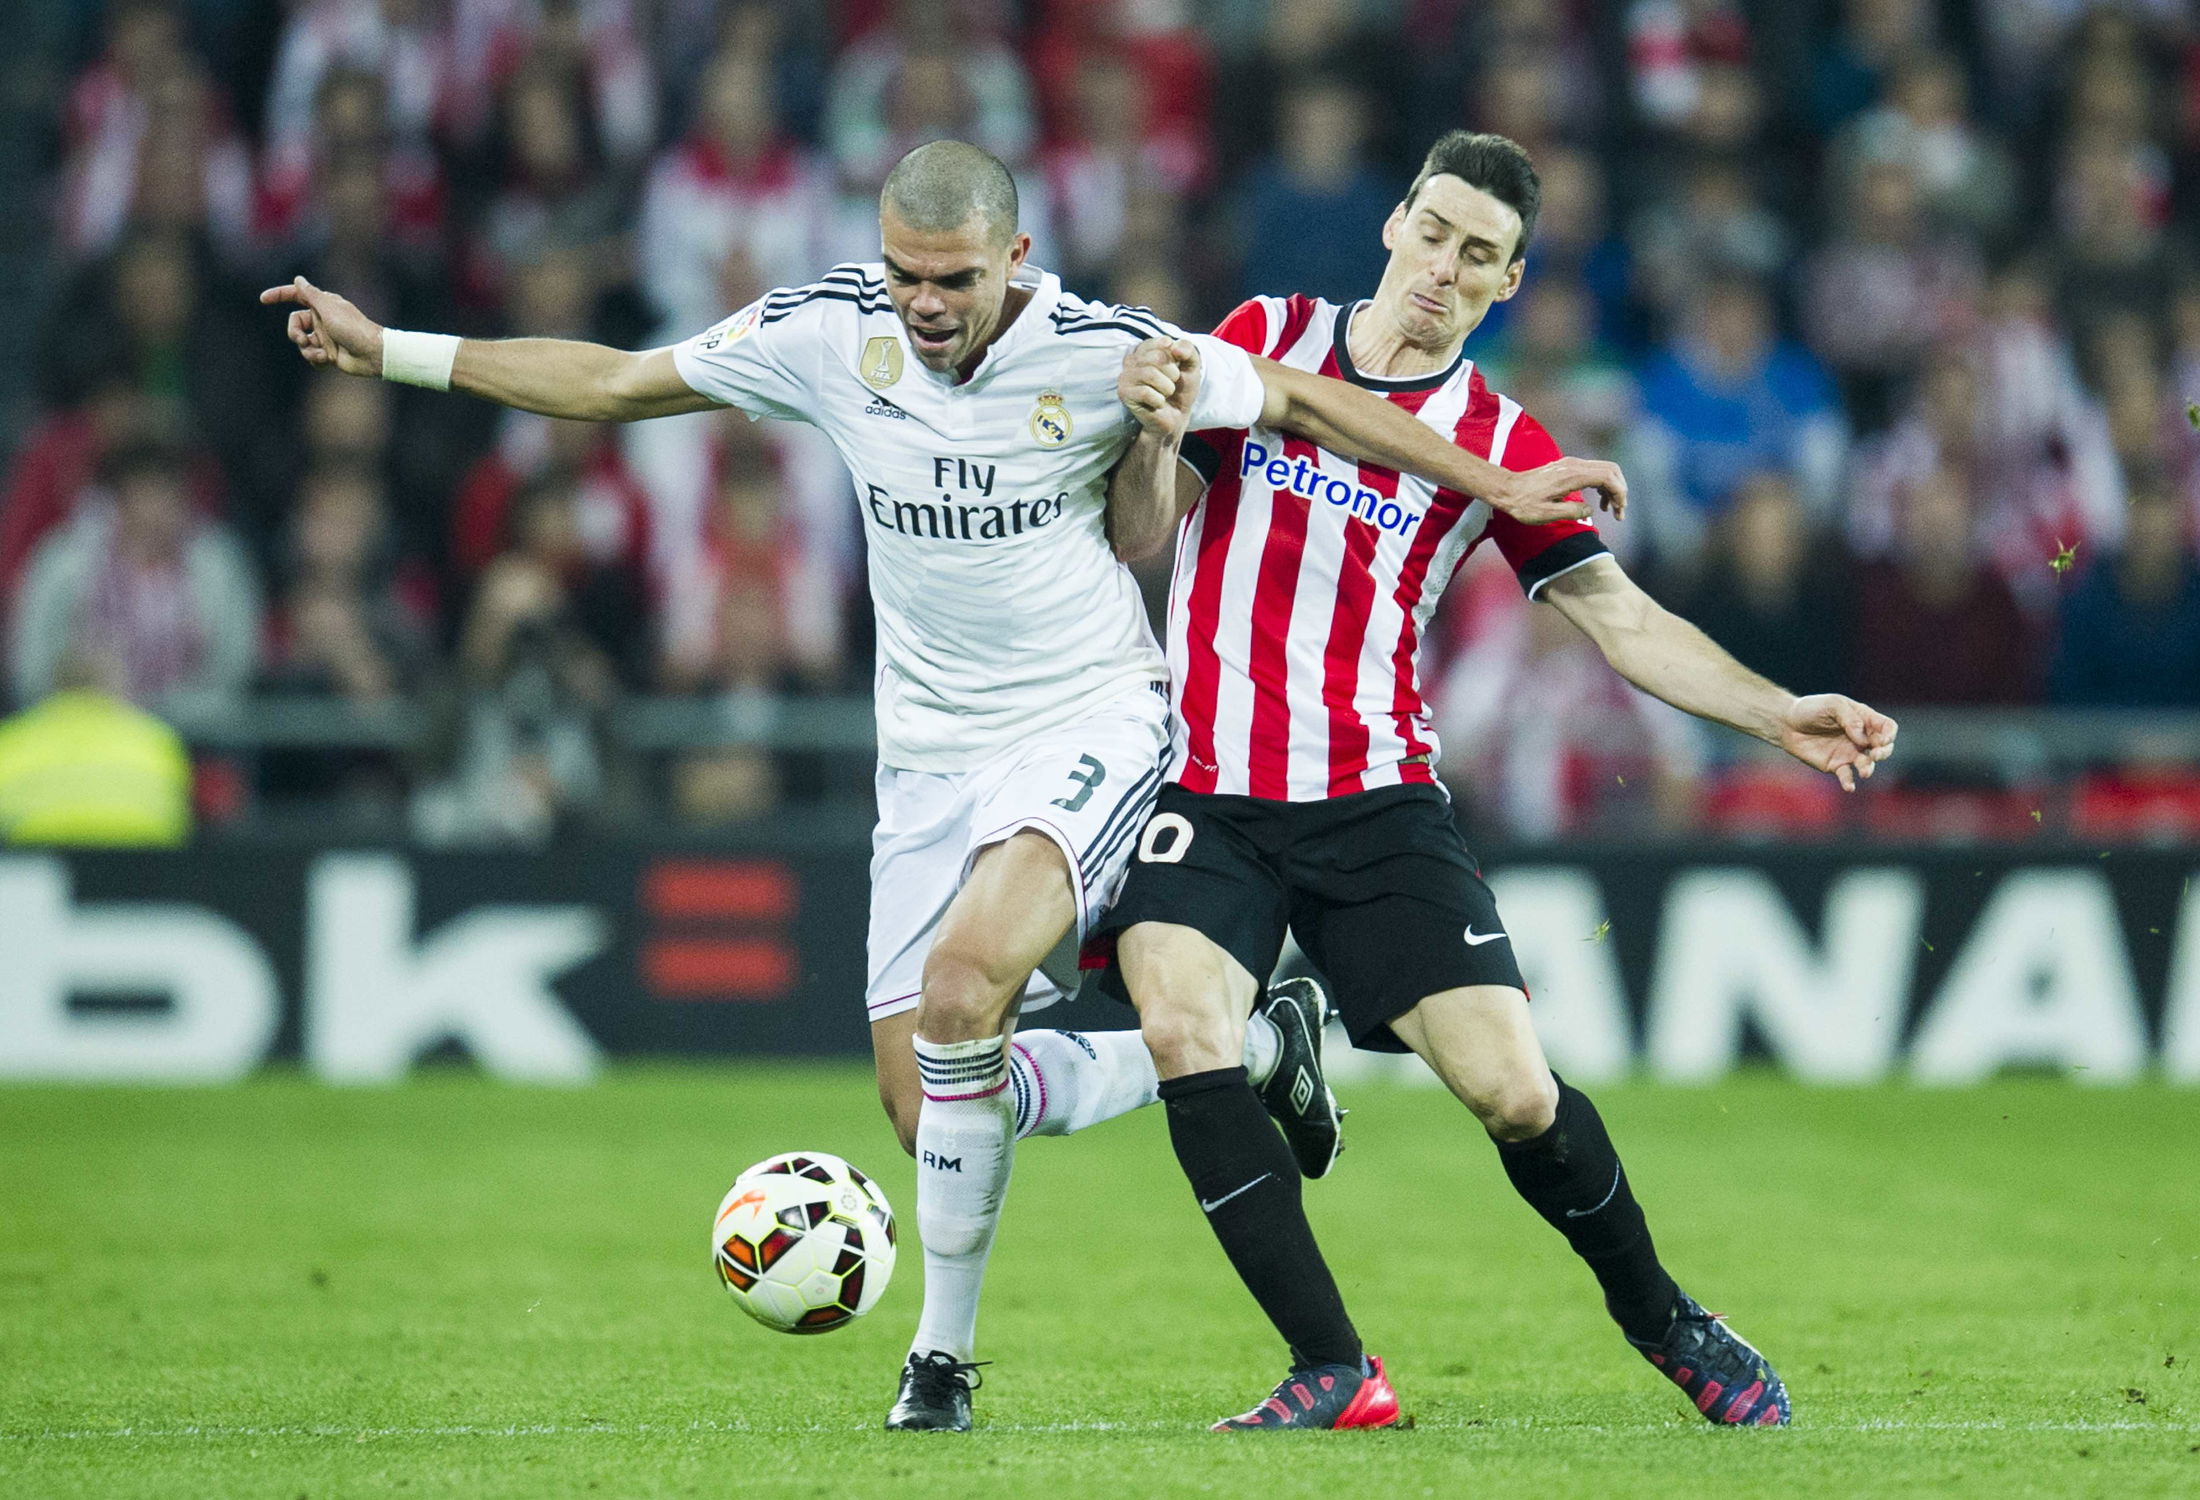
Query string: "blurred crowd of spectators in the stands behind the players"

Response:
xmin=0 ymin=0 xmax=2200 ymax=840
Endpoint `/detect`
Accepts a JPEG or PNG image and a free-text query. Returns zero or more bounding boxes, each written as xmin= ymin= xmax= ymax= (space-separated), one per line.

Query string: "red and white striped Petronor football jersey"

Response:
xmin=1168 ymin=297 xmax=1606 ymax=801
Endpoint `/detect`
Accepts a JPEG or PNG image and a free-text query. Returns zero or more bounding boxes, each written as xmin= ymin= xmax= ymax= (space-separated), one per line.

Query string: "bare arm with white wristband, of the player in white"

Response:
xmin=260 ymin=277 xmax=717 ymax=422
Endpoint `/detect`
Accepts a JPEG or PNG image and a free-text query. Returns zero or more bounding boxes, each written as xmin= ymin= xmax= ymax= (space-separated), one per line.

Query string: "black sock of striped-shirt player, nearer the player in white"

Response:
xmin=1162 ymin=1067 xmax=1360 ymax=1366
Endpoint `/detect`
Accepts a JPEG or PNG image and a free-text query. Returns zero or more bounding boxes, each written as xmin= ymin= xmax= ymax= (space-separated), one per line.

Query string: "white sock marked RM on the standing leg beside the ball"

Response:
xmin=909 ymin=1036 xmax=1016 ymax=1359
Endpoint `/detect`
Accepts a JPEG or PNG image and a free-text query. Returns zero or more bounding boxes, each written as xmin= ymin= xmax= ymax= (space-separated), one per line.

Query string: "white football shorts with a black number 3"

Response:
xmin=865 ymin=688 xmax=1168 ymax=1021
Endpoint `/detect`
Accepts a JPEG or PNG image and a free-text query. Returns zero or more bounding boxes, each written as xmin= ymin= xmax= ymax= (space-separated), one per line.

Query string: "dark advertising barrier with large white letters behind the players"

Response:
xmin=0 ymin=842 xmax=2200 ymax=1084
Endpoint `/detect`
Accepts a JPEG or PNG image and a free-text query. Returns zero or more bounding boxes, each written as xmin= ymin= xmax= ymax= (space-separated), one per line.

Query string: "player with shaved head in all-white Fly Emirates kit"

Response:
xmin=260 ymin=141 xmax=1624 ymax=1430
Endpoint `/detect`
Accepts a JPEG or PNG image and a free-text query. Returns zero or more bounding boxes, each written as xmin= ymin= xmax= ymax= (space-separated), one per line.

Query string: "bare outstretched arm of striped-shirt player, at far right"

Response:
xmin=1540 ymin=556 xmax=1896 ymax=792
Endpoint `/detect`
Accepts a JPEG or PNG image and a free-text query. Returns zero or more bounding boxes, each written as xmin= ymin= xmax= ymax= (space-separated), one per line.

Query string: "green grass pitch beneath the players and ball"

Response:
xmin=0 ymin=1065 xmax=2200 ymax=1500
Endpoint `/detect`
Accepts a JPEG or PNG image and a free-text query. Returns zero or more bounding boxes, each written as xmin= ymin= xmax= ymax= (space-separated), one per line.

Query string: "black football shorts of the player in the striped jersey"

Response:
xmin=1096 ymin=785 xmax=1527 ymax=1051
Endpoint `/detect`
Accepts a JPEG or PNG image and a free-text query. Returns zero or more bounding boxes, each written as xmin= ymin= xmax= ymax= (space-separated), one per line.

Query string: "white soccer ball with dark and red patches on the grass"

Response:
xmin=711 ymin=1150 xmax=893 ymax=1333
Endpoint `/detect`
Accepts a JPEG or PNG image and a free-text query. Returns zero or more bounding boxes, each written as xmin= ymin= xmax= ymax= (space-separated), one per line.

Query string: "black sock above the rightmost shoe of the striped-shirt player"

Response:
xmin=1496 ymin=1073 xmax=1681 ymax=1342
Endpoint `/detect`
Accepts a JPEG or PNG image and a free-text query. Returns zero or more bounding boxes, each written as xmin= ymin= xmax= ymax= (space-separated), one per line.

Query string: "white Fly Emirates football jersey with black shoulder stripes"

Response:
xmin=673 ymin=264 xmax=1263 ymax=772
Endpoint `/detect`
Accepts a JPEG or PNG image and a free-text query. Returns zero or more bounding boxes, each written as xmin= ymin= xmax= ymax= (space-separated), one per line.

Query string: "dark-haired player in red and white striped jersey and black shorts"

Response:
xmin=1100 ymin=132 xmax=1894 ymax=1430
